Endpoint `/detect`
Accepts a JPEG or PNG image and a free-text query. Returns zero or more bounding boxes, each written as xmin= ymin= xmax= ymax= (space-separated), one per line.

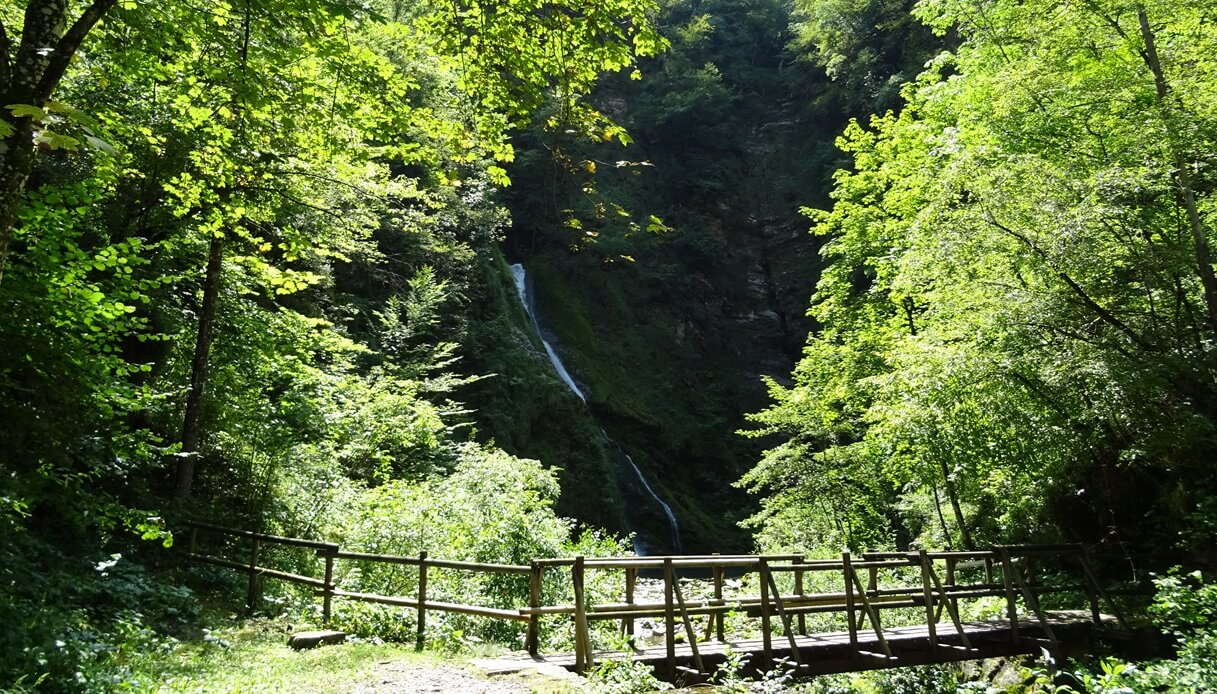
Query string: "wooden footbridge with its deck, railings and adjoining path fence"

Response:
xmin=187 ymin=522 xmax=1128 ymax=683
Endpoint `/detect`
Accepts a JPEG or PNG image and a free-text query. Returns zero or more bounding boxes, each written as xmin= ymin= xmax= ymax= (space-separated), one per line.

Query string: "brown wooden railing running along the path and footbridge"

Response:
xmin=180 ymin=522 xmax=1127 ymax=678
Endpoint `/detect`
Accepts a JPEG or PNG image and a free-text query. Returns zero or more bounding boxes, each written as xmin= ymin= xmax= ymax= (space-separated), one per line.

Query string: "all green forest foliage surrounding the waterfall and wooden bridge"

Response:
xmin=0 ymin=0 xmax=1217 ymax=690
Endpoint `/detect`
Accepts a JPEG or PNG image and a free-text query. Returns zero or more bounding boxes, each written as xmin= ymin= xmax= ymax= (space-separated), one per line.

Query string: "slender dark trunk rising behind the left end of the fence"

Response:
xmin=173 ymin=236 xmax=224 ymax=499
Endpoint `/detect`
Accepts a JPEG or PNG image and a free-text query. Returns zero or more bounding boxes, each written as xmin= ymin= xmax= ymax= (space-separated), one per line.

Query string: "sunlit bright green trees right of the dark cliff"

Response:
xmin=745 ymin=0 xmax=1217 ymax=565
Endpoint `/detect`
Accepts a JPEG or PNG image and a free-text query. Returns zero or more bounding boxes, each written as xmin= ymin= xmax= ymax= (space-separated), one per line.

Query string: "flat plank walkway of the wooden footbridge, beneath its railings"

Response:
xmin=473 ymin=615 xmax=1094 ymax=683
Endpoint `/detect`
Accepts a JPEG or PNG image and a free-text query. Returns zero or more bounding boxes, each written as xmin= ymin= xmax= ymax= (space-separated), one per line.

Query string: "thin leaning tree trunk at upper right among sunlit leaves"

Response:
xmin=1137 ymin=7 xmax=1217 ymax=330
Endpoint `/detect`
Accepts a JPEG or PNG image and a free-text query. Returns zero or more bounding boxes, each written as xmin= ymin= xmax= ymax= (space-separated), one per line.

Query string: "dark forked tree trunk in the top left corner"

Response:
xmin=0 ymin=0 xmax=116 ymax=280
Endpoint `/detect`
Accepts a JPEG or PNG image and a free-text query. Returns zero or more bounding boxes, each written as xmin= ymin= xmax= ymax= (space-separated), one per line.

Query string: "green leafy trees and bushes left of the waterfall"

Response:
xmin=0 ymin=0 xmax=663 ymax=689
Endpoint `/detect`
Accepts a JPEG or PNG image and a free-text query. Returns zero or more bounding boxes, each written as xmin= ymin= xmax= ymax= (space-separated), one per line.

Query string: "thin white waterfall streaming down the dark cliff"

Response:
xmin=511 ymin=263 xmax=683 ymax=556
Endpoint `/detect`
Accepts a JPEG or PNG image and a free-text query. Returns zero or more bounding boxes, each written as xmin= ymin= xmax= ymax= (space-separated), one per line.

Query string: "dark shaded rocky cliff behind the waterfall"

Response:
xmin=460 ymin=0 xmax=843 ymax=552
